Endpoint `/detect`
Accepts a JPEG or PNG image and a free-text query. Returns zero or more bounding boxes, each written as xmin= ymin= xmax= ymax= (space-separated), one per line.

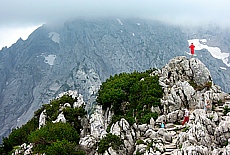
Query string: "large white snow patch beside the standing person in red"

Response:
xmin=188 ymin=39 xmax=230 ymax=67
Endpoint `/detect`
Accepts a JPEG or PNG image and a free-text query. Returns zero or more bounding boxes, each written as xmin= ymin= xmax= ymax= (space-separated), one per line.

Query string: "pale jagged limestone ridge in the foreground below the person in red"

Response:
xmin=12 ymin=56 xmax=230 ymax=155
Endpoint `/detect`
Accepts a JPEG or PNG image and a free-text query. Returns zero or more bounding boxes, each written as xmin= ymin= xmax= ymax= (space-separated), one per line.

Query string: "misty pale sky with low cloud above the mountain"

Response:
xmin=0 ymin=0 xmax=230 ymax=49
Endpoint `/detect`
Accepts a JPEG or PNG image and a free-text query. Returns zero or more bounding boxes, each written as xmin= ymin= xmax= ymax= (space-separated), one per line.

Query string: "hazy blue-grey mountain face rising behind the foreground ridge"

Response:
xmin=0 ymin=19 xmax=230 ymax=141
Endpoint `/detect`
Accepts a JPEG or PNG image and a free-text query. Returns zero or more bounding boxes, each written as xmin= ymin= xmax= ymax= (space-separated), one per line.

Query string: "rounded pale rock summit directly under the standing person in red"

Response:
xmin=155 ymin=56 xmax=212 ymax=87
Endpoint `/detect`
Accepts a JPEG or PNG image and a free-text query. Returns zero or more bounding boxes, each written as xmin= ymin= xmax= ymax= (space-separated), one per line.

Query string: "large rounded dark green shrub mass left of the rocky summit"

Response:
xmin=97 ymin=70 xmax=163 ymax=125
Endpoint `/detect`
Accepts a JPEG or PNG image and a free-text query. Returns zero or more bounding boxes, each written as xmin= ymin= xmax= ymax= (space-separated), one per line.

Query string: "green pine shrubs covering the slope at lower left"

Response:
xmin=0 ymin=95 xmax=86 ymax=155
